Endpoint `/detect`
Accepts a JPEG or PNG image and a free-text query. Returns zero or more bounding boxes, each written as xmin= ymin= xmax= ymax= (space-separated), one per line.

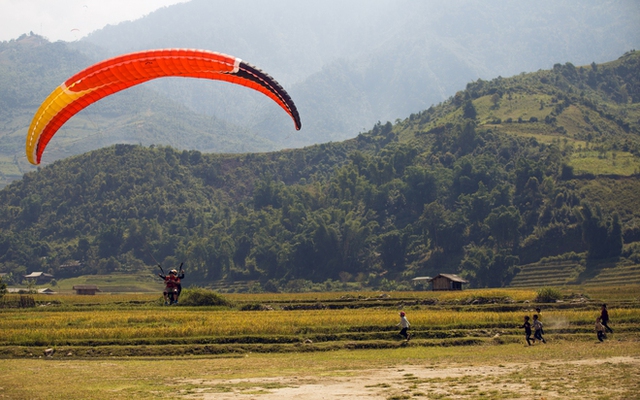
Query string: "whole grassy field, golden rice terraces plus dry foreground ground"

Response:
xmin=0 ymin=285 xmax=640 ymax=400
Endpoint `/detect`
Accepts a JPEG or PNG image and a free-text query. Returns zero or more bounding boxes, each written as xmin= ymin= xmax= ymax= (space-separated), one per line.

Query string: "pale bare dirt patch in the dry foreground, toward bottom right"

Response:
xmin=184 ymin=357 xmax=640 ymax=400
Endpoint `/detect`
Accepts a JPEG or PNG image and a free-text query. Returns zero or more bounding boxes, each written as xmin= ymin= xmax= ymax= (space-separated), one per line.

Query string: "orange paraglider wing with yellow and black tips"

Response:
xmin=26 ymin=49 xmax=302 ymax=165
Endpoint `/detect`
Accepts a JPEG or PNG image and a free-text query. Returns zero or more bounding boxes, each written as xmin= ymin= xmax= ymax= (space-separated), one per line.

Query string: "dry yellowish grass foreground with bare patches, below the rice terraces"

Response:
xmin=0 ymin=338 xmax=640 ymax=400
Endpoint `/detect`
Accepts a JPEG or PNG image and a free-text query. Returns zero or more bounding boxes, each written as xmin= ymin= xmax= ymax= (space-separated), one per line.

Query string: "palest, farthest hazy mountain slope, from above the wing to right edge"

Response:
xmin=83 ymin=0 xmax=640 ymax=147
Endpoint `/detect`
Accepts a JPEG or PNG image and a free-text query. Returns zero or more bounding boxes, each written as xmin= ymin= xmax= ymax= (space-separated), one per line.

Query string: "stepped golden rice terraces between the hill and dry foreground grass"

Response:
xmin=0 ymin=288 xmax=640 ymax=349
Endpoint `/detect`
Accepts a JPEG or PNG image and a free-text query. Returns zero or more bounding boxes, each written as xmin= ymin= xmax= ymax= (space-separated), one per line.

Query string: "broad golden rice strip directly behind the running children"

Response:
xmin=0 ymin=307 xmax=640 ymax=345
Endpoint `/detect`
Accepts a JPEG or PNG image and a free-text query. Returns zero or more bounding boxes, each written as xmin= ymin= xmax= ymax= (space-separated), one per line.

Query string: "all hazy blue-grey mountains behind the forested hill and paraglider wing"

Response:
xmin=0 ymin=0 xmax=640 ymax=185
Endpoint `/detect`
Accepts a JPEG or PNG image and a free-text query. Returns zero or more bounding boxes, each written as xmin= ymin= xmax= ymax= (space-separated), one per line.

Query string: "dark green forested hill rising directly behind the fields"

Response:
xmin=0 ymin=52 xmax=640 ymax=290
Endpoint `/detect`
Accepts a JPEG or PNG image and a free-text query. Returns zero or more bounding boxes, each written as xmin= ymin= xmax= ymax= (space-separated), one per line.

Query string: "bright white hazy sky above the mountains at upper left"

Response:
xmin=0 ymin=0 xmax=188 ymax=42
